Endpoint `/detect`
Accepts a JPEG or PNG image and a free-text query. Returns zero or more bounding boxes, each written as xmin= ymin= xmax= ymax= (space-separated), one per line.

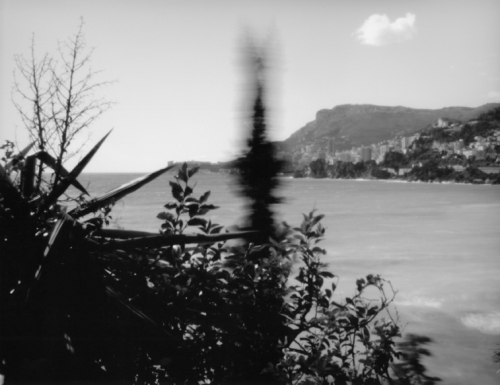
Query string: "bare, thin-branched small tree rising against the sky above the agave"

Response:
xmin=13 ymin=20 xmax=112 ymax=191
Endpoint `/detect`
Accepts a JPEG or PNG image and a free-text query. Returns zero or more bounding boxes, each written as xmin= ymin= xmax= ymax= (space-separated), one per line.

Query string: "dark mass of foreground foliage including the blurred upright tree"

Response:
xmin=0 ymin=32 xmax=440 ymax=385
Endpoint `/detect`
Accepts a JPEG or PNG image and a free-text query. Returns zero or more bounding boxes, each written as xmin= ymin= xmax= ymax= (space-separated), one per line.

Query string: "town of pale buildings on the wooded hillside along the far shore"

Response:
xmin=277 ymin=108 xmax=500 ymax=184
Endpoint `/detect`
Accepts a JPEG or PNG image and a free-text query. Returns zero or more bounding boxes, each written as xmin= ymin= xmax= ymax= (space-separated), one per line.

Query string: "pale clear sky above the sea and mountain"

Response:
xmin=0 ymin=0 xmax=500 ymax=172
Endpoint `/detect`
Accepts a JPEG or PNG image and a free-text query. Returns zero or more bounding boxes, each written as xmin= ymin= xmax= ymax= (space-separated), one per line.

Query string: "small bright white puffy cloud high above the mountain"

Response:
xmin=354 ymin=13 xmax=417 ymax=47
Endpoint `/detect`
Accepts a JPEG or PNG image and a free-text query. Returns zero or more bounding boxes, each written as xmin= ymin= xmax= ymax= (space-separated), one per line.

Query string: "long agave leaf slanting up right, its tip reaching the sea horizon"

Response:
xmin=69 ymin=165 xmax=175 ymax=218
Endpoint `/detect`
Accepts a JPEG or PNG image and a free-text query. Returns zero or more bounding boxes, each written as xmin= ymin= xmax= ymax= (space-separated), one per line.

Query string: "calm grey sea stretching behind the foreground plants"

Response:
xmin=71 ymin=171 xmax=500 ymax=385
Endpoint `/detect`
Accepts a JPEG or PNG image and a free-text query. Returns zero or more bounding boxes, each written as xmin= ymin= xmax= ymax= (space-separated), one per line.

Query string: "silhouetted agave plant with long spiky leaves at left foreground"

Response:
xmin=0 ymin=133 xmax=255 ymax=381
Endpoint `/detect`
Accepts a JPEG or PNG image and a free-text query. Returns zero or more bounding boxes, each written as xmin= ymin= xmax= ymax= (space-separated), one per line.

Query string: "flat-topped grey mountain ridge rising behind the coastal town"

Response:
xmin=277 ymin=103 xmax=500 ymax=150
